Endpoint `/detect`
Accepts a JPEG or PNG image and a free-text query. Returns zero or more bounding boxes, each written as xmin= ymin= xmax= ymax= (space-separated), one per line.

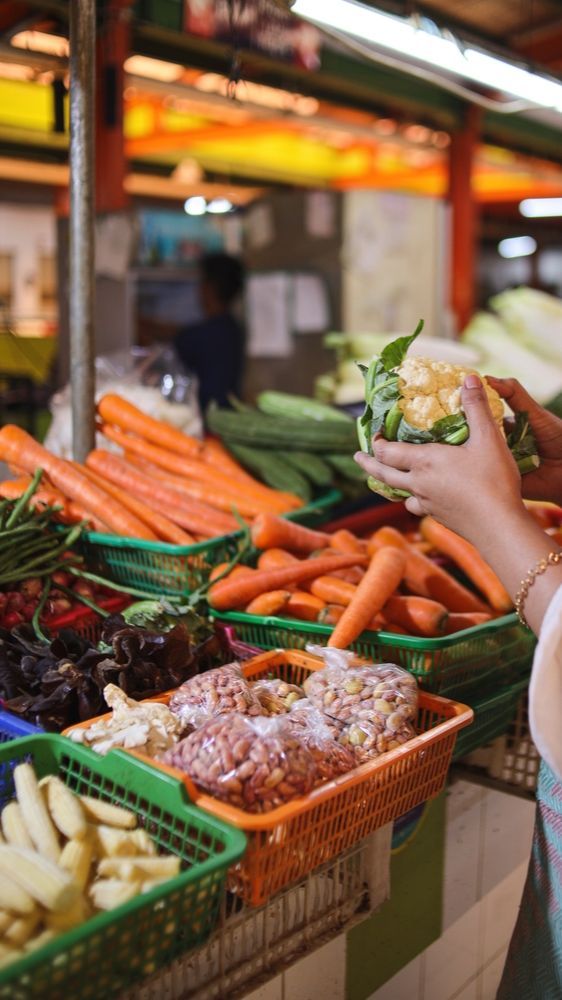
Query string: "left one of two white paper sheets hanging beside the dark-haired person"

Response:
xmin=246 ymin=271 xmax=292 ymax=358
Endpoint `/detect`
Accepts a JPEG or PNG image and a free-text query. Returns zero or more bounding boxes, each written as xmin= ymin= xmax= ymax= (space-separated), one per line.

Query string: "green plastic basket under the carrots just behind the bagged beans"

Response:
xmin=214 ymin=611 xmax=536 ymax=701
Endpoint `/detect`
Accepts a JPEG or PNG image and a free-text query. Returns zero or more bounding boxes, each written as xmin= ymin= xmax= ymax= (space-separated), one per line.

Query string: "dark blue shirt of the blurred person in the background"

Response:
xmin=174 ymin=313 xmax=244 ymax=414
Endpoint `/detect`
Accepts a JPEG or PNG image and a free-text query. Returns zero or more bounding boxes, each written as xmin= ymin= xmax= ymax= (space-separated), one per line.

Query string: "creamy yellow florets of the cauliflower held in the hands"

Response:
xmin=398 ymin=357 xmax=504 ymax=430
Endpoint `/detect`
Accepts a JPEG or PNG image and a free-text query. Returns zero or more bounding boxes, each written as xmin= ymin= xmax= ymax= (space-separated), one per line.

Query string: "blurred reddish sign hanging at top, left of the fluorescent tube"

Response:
xmin=184 ymin=0 xmax=320 ymax=70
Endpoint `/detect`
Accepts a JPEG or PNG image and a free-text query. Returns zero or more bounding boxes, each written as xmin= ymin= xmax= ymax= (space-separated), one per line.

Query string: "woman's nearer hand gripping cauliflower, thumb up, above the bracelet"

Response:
xmin=355 ymin=375 xmax=523 ymax=544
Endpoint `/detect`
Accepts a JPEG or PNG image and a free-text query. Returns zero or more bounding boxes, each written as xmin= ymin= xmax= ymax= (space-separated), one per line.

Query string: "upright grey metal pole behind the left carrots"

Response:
xmin=68 ymin=0 xmax=96 ymax=462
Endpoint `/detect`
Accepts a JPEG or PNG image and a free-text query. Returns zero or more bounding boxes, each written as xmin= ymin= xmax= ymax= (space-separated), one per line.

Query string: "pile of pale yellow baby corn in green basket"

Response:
xmin=0 ymin=763 xmax=180 ymax=966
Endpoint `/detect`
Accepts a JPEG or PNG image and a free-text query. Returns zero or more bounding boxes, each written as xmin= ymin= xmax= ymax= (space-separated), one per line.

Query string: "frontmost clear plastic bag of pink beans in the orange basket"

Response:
xmin=164 ymin=713 xmax=317 ymax=813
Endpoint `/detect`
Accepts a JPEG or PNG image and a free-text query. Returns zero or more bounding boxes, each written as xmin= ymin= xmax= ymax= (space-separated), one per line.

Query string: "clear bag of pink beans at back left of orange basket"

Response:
xmin=169 ymin=663 xmax=264 ymax=728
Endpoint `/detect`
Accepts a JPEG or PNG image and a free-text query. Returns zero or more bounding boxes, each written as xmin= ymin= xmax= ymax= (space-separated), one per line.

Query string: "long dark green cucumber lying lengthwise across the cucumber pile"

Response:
xmin=206 ymin=405 xmax=357 ymax=453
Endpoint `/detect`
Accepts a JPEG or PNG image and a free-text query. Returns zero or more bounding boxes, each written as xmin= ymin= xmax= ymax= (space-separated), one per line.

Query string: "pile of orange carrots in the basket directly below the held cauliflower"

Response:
xmin=208 ymin=513 xmax=513 ymax=649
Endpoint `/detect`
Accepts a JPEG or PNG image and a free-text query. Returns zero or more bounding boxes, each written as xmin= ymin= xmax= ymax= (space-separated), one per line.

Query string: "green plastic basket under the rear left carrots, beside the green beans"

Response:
xmin=76 ymin=490 xmax=342 ymax=596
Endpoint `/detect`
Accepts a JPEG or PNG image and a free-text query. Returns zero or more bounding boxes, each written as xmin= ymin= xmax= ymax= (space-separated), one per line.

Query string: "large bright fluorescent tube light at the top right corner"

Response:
xmin=291 ymin=0 xmax=562 ymax=112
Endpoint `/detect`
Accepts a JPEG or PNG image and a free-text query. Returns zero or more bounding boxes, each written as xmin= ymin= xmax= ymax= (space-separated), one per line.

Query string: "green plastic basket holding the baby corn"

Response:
xmin=0 ymin=735 xmax=246 ymax=1000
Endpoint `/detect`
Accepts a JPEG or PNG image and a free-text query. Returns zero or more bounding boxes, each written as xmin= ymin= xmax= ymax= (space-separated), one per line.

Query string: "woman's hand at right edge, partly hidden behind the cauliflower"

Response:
xmin=486 ymin=375 xmax=562 ymax=504
